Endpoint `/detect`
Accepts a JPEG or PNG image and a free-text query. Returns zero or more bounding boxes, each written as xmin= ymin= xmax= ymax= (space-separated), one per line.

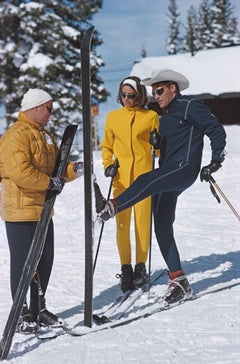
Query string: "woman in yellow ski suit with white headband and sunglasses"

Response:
xmin=101 ymin=76 xmax=159 ymax=292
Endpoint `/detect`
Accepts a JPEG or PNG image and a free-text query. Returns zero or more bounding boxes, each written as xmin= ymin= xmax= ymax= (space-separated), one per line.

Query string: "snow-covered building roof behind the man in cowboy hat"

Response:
xmin=130 ymin=46 xmax=240 ymax=97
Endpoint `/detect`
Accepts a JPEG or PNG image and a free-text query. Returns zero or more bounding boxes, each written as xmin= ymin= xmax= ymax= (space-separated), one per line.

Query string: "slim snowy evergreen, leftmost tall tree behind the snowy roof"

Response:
xmin=166 ymin=0 xmax=180 ymax=54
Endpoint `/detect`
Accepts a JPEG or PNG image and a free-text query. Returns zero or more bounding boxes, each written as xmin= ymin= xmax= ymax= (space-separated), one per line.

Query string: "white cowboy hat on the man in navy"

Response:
xmin=141 ymin=69 xmax=189 ymax=91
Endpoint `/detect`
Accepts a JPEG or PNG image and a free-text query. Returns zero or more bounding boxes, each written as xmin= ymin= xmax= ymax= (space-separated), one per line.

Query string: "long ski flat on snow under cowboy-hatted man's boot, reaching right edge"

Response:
xmin=63 ymin=281 xmax=240 ymax=336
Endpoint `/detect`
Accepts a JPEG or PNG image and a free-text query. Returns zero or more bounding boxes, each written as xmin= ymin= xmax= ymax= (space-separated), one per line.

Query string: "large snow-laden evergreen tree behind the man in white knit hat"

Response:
xmin=0 ymin=0 xmax=108 ymax=136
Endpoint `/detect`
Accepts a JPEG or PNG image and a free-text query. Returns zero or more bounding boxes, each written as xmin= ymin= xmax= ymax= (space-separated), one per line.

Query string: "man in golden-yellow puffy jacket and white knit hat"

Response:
xmin=0 ymin=89 xmax=83 ymax=333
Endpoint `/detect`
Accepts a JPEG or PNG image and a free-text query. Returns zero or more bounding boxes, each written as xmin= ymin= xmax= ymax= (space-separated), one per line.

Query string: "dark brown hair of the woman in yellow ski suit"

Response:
xmin=117 ymin=76 xmax=148 ymax=108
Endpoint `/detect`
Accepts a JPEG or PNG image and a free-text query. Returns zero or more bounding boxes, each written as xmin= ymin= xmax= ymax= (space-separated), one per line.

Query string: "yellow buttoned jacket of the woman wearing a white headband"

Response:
xmin=101 ymin=106 xmax=159 ymax=188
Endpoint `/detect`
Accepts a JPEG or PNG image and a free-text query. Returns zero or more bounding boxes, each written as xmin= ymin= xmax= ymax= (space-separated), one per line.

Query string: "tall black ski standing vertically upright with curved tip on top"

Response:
xmin=81 ymin=27 xmax=94 ymax=327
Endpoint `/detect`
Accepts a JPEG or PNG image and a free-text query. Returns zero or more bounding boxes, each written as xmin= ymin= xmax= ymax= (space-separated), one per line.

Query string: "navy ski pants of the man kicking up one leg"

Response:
xmin=115 ymin=161 xmax=200 ymax=272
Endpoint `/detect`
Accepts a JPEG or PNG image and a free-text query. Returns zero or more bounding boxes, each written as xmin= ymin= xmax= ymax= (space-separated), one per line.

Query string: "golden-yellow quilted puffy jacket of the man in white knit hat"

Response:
xmin=0 ymin=112 xmax=76 ymax=221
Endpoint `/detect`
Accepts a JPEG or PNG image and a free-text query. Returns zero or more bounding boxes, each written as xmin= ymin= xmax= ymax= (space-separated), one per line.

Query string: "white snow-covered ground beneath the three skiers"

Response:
xmin=0 ymin=125 xmax=240 ymax=364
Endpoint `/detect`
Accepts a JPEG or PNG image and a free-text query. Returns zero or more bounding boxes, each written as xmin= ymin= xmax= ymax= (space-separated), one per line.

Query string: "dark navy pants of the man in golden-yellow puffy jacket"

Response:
xmin=5 ymin=219 xmax=54 ymax=304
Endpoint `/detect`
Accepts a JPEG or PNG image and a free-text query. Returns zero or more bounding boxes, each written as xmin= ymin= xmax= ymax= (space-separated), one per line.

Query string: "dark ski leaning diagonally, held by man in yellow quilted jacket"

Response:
xmin=0 ymin=125 xmax=77 ymax=360
